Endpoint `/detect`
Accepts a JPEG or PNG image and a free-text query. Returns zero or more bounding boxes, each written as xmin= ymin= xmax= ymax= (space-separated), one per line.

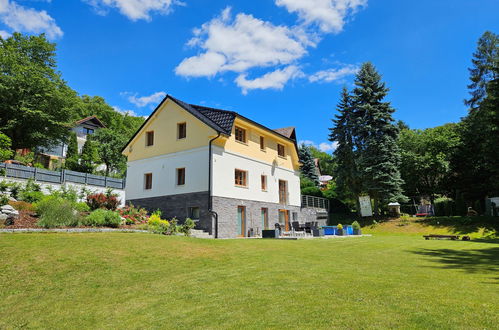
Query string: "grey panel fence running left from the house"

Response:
xmin=0 ymin=163 xmax=125 ymax=189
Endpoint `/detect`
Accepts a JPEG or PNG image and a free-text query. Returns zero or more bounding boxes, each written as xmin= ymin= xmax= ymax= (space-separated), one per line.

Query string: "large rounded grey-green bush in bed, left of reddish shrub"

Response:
xmin=35 ymin=196 xmax=80 ymax=228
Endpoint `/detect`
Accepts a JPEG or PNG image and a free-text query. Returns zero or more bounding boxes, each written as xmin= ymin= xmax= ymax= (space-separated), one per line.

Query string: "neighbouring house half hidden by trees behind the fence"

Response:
xmin=38 ymin=116 xmax=106 ymax=168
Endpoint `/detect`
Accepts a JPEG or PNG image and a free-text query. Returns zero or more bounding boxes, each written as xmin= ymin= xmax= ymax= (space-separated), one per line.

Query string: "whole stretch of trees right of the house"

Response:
xmin=300 ymin=31 xmax=499 ymax=215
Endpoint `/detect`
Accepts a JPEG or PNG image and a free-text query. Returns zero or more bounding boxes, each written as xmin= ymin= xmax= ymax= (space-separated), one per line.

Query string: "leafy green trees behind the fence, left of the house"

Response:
xmin=0 ymin=33 xmax=144 ymax=175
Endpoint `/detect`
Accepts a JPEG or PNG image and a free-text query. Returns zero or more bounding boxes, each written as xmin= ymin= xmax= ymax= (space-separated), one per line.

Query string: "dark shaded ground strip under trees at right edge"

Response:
xmin=416 ymin=216 xmax=499 ymax=235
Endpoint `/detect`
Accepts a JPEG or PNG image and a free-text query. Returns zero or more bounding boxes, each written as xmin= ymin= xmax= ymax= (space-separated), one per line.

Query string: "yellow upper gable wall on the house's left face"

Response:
xmin=123 ymin=99 xmax=217 ymax=161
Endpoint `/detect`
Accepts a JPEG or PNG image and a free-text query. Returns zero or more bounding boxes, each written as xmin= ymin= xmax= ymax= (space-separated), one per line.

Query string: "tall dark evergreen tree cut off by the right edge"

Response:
xmin=452 ymin=31 xmax=499 ymax=201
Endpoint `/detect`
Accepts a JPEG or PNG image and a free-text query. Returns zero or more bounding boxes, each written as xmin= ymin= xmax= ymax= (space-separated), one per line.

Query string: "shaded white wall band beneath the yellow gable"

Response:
xmin=125 ymin=146 xmax=208 ymax=200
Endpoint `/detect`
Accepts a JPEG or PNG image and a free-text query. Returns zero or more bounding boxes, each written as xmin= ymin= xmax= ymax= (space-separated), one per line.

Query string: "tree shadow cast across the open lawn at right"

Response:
xmin=409 ymin=244 xmax=499 ymax=283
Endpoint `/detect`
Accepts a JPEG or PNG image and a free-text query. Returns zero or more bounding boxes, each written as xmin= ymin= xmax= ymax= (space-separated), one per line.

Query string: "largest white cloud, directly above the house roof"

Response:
xmin=175 ymin=7 xmax=316 ymax=91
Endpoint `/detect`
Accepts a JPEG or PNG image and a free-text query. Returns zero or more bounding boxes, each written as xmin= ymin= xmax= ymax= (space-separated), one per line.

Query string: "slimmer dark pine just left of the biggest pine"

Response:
xmin=329 ymin=87 xmax=361 ymax=203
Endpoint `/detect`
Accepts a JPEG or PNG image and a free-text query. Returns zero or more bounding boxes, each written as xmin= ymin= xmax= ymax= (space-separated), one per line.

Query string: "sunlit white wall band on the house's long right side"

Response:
xmin=212 ymin=147 xmax=301 ymax=206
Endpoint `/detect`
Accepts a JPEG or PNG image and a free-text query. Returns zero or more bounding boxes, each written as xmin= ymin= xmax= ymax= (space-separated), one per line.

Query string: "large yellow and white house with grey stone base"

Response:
xmin=123 ymin=95 xmax=308 ymax=237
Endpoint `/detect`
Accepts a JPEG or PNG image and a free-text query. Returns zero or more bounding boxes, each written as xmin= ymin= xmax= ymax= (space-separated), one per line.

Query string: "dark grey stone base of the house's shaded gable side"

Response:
xmin=127 ymin=191 xmax=212 ymax=234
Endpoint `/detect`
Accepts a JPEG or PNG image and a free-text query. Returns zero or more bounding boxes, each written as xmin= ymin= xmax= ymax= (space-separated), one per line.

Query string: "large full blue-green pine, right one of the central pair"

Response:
xmin=352 ymin=62 xmax=406 ymax=214
